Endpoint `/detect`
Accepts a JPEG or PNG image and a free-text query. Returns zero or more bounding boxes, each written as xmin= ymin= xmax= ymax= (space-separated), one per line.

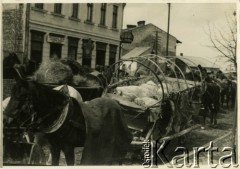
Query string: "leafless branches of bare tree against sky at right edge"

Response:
xmin=206 ymin=12 xmax=237 ymax=68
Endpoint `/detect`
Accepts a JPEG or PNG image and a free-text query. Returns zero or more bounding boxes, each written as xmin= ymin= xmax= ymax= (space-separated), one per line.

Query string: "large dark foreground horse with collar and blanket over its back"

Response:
xmin=4 ymin=78 xmax=132 ymax=165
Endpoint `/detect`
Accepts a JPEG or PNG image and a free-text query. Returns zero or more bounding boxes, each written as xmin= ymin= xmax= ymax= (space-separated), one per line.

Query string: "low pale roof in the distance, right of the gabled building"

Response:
xmin=178 ymin=56 xmax=220 ymax=68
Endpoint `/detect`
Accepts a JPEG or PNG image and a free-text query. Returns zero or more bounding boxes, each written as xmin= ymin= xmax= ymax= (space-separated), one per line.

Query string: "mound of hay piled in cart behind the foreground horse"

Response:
xmin=33 ymin=59 xmax=102 ymax=87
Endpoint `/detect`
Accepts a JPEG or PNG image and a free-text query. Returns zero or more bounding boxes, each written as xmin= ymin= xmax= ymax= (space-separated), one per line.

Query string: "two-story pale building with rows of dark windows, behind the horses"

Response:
xmin=3 ymin=3 xmax=125 ymax=68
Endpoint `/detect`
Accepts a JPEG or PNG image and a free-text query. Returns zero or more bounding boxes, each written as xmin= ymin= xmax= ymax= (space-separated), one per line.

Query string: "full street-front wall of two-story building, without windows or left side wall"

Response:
xmin=28 ymin=3 xmax=124 ymax=68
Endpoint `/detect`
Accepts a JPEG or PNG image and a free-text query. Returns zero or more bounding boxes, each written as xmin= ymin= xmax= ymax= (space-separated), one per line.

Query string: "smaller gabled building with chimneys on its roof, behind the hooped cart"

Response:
xmin=122 ymin=21 xmax=182 ymax=56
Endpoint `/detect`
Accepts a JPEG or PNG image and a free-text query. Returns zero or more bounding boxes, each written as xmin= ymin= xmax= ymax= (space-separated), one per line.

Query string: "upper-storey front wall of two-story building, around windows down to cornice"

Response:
xmin=30 ymin=3 xmax=123 ymax=41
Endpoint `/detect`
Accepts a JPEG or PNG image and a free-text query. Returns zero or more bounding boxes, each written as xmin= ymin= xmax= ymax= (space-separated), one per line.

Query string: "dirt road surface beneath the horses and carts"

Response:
xmin=4 ymin=109 xmax=236 ymax=166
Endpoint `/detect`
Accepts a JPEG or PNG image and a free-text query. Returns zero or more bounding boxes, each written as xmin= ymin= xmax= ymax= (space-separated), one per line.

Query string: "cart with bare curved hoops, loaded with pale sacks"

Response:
xmin=103 ymin=54 xmax=202 ymax=164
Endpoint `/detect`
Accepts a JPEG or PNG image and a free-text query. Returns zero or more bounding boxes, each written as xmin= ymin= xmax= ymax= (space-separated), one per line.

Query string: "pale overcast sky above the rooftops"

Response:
xmin=123 ymin=3 xmax=236 ymax=69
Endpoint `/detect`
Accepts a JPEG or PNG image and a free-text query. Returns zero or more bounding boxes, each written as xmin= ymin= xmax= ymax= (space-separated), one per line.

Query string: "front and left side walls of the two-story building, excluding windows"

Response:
xmin=3 ymin=3 xmax=125 ymax=68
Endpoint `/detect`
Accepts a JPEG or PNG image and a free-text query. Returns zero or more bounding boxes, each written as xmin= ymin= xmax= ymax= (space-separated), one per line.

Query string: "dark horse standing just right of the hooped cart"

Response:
xmin=201 ymin=81 xmax=220 ymax=126
